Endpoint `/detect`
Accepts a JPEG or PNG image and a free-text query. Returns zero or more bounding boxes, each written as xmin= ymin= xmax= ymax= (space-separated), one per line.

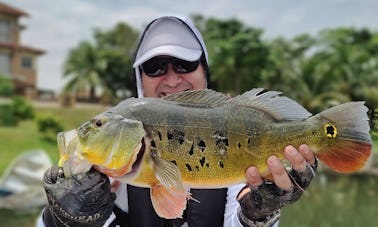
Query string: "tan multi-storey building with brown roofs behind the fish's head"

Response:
xmin=0 ymin=2 xmax=44 ymax=99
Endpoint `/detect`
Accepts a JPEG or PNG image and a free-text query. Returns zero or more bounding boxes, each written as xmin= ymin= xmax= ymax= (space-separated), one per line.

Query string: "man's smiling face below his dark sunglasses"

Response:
xmin=142 ymin=57 xmax=207 ymax=98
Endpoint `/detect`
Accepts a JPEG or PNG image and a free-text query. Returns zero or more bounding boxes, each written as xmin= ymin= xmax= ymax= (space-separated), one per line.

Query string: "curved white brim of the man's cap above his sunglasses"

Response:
xmin=133 ymin=45 xmax=202 ymax=67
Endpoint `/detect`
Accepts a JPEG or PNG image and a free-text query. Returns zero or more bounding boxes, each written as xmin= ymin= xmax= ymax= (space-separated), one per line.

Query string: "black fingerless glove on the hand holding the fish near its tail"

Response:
xmin=238 ymin=159 xmax=318 ymax=226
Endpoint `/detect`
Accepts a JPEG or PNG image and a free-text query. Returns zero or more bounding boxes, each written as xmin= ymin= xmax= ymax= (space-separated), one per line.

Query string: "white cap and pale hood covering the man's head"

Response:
xmin=133 ymin=16 xmax=208 ymax=98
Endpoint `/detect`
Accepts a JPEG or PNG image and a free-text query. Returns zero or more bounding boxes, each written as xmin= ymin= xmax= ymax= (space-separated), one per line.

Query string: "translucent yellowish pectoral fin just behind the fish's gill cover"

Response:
xmin=151 ymin=153 xmax=184 ymax=191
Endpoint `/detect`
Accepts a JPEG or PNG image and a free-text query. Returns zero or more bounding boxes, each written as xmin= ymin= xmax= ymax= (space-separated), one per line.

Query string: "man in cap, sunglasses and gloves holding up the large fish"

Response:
xmin=40 ymin=16 xmax=316 ymax=227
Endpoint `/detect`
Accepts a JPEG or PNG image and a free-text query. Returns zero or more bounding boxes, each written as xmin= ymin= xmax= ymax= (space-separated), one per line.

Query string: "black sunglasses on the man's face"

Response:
xmin=140 ymin=57 xmax=200 ymax=77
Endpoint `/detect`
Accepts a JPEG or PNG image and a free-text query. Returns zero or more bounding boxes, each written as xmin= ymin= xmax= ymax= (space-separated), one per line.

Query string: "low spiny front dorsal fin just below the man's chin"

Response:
xmin=163 ymin=89 xmax=230 ymax=107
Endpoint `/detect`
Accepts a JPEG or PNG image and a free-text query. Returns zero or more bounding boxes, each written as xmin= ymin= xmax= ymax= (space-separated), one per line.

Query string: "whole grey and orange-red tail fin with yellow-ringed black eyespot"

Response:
xmin=313 ymin=102 xmax=372 ymax=173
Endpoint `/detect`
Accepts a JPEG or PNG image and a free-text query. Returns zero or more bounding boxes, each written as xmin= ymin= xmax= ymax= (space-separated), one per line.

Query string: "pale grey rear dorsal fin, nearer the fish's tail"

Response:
xmin=229 ymin=88 xmax=312 ymax=121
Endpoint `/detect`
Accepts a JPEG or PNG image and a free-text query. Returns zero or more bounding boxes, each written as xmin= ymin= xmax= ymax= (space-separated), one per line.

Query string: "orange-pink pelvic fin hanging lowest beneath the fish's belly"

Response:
xmin=150 ymin=184 xmax=188 ymax=219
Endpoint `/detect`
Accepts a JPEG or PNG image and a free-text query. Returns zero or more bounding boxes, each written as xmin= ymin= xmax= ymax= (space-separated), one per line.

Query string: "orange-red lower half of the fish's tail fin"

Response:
xmin=316 ymin=140 xmax=372 ymax=173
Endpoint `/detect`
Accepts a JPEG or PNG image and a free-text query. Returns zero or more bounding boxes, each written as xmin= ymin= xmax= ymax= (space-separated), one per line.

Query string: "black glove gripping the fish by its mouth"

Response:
xmin=42 ymin=166 xmax=115 ymax=227
